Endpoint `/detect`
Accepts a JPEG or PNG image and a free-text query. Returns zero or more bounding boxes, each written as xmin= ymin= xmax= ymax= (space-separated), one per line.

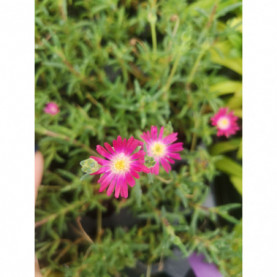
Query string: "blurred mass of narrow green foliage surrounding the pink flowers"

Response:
xmin=35 ymin=0 xmax=242 ymax=277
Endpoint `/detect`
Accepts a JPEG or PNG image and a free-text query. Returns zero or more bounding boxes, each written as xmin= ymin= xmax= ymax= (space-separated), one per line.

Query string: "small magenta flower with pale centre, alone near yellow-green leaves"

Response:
xmin=211 ymin=108 xmax=239 ymax=138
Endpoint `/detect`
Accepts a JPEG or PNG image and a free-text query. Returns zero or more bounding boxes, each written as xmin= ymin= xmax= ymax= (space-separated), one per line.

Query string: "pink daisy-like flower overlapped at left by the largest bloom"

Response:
xmin=141 ymin=126 xmax=184 ymax=175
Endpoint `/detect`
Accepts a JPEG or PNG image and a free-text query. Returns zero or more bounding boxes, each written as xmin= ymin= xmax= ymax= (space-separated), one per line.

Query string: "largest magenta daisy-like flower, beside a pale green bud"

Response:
xmin=90 ymin=136 xmax=150 ymax=198
